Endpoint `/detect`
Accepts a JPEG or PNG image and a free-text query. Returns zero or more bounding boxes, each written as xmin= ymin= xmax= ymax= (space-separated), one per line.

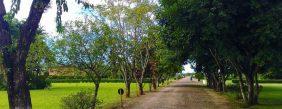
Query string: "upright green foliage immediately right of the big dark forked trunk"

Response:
xmin=26 ymin=35 xmax=55 ymax=89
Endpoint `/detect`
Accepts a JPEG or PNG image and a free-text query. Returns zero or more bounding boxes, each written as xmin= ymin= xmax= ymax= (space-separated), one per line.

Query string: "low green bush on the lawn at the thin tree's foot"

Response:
xmin=61 ymin=91 xmax=102 ymax=109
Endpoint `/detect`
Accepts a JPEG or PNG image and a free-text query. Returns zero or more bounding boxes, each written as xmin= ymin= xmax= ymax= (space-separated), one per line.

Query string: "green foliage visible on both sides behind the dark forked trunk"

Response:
xmin=1 ymin=14 xmax=55 ymax=89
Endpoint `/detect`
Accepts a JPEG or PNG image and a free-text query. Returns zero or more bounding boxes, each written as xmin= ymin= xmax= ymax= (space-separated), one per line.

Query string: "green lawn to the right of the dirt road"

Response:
xmin=227 ymin=83 xmax=282 ymax=109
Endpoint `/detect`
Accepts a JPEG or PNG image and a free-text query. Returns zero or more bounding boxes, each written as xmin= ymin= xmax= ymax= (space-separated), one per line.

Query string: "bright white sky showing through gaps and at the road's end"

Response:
xmin=4 ymin=0 xmax=194 ymax=73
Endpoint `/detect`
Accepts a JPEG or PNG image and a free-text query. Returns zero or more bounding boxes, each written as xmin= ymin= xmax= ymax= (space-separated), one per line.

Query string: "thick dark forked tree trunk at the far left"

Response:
xmin=0 ymin=0 xmax=50 ymax=109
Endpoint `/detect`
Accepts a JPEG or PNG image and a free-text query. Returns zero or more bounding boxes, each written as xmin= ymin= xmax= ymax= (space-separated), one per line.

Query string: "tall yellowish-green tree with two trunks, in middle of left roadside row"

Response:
xmin=94 ymin=0 xmax=159 ymax=97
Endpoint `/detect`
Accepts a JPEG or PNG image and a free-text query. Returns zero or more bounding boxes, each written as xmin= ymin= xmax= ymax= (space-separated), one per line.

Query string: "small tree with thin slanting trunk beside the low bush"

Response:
xmin=56 ymin=20 xmax=111 ymax=108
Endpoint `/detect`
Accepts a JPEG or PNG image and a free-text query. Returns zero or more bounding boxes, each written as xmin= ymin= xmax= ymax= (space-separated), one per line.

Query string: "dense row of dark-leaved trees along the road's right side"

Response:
xmin=159 ymin=0 xmax=282 ymax=105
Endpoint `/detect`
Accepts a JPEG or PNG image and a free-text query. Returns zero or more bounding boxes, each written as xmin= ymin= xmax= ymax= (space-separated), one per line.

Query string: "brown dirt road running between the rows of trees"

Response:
xmin=120 ymin=78 xmax=235 ymax=109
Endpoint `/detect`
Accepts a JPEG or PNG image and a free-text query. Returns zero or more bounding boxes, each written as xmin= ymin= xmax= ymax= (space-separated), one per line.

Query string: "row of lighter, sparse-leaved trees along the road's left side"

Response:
xmin=54 ymin=0 xmax=182 ymax=107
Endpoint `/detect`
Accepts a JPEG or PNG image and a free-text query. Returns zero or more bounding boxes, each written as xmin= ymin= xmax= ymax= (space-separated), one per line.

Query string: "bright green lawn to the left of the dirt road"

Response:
xmin=0 ymin=83 xmax=149 ymax=109
